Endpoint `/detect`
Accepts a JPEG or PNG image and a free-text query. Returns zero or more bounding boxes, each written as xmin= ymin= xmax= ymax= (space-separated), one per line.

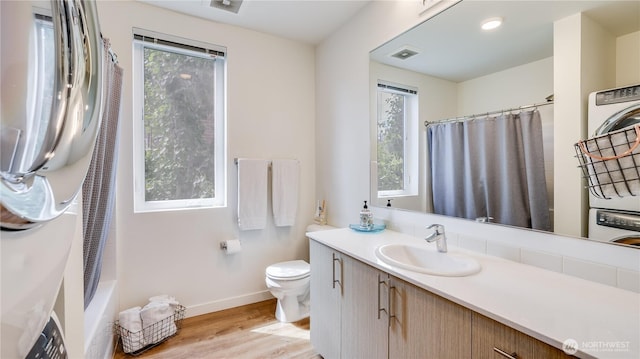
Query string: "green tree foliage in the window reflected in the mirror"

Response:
xmin=378 ymin=91 xmax=405 ymax=191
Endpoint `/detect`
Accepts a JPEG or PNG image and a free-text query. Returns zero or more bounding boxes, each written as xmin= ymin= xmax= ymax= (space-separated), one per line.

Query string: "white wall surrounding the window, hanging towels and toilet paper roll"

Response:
xmin=98 ymin=1 xmax=315 ymax=316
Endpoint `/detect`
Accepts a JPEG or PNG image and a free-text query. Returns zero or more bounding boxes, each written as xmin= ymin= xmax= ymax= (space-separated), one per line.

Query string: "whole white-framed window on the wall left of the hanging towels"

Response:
xmin=133 ymin=29 xmax=226 ymax=212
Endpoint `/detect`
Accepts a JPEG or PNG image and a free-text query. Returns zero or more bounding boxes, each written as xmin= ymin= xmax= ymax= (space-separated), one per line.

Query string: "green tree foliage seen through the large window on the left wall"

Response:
xmin=144 ymin=47 xmax=215 ymax=201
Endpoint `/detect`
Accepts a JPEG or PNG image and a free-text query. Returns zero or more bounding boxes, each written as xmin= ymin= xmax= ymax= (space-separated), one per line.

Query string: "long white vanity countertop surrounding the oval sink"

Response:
xmin=307 ymin=228 xmax=640 ymax=359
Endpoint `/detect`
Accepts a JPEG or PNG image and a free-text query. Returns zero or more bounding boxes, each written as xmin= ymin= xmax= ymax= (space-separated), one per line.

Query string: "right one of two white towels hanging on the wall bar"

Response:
xmin=271 ymin=160 xmax=300 ymax=227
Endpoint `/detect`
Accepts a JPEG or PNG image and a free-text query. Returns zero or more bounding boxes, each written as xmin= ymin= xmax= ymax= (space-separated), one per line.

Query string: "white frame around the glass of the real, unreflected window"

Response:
xmin=132 ymin=28 xmax=227 ymax=213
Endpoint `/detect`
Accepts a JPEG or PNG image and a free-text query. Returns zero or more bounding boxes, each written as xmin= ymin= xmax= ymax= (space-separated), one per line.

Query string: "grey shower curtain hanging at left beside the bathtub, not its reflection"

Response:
xmin=82 ymin=39 xmax=122 ymax=309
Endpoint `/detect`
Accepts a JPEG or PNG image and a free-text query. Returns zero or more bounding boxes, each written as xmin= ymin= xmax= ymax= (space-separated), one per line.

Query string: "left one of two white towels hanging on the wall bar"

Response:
xmin=238 ymin=158 xmax=269 ymax=231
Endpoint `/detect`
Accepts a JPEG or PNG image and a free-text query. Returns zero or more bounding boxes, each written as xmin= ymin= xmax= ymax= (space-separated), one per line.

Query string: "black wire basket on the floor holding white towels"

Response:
xmin=113 ymin=305 xmax=185 ymax=356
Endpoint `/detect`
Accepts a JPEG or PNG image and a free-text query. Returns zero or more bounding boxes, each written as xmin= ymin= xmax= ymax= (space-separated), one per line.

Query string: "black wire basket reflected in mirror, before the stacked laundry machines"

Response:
xmin=574 ymin=125 xmax=640 ymax=199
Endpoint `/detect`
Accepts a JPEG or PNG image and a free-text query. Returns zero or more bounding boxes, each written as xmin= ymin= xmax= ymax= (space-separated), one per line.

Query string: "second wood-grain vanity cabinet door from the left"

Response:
xmin=342 ymin=256 xmax=389 ymax=359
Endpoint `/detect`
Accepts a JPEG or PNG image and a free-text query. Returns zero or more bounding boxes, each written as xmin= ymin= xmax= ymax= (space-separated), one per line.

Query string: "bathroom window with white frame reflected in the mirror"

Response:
xmin=377 ymin=81 xmax=418 ymax=198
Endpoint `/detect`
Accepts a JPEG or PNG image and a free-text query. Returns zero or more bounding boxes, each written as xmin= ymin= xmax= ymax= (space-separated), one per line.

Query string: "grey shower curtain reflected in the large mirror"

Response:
xmin=427 ymin=110 xmax=551 ymax=230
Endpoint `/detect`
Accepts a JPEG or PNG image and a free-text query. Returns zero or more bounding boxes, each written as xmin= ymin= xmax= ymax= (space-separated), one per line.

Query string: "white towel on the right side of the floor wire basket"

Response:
xmin=140 ymin=302 xmax=178 ymax=344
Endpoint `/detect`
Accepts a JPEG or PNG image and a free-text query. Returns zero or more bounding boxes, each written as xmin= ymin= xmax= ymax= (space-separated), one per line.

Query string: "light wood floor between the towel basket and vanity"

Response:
xmin=114 ymin=299 xmax=322 ymax=359
